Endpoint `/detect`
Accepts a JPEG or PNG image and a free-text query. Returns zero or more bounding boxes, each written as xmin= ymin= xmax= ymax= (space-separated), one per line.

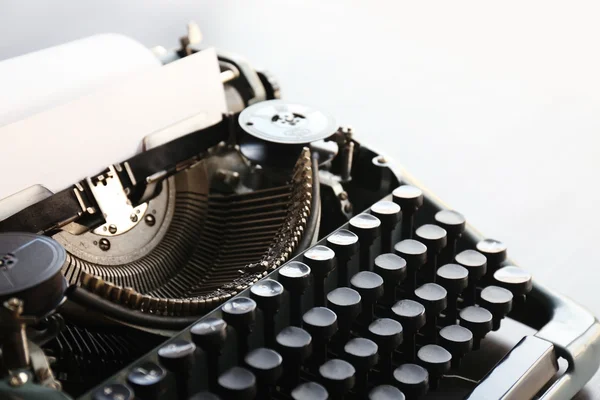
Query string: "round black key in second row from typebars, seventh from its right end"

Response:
xmin=302 ymin=307 xmax=338 ymax=365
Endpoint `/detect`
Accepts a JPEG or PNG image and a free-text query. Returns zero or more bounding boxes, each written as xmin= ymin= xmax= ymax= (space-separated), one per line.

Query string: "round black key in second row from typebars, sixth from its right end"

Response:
xmin=327 ymin=287 xmax=361 ymax=346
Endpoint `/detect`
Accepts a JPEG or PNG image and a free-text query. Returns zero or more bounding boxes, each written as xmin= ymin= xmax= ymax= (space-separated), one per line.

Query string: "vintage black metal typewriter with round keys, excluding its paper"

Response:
xmin=0 ymin=25 xmax=600 ymax=400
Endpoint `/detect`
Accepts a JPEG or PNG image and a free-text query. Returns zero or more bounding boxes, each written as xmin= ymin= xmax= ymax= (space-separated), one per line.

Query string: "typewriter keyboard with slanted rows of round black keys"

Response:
xmin=86 ymin=185 xmax=558 ymax=400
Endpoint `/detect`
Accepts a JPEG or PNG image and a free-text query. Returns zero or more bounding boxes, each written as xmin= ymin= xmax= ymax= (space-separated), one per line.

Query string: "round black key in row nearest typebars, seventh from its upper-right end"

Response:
xmin=250 ymin=278 xmax=283 ymax=347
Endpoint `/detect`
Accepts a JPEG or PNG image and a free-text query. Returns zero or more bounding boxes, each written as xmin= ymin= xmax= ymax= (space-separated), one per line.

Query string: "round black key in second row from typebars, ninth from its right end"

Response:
xmin=245 ymin=347 xmax=283 ymax=399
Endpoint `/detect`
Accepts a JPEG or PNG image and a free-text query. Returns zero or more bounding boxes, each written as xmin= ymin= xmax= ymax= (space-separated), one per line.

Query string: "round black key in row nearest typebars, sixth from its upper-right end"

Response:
xmin=278 ymin=261 xmax=311 ymax=326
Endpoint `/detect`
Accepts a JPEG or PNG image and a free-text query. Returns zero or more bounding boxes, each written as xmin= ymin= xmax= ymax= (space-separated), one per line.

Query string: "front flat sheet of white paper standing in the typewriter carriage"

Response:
xmin=0 ymin=49 xmax=226 ymax=199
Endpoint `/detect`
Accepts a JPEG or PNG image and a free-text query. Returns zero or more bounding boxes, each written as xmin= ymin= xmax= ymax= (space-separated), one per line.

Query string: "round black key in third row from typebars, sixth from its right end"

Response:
xmin=369 ymin=318 xmax=403 ymax=379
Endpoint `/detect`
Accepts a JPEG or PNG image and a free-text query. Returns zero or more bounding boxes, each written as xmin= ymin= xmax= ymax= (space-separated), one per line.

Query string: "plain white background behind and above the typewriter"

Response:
xmin=0 ymin=0 xmax=600 ymax=398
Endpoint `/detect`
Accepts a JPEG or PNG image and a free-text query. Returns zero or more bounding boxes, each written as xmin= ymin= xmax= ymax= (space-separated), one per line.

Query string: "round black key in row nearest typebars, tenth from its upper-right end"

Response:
xmin=158 ymin=339 xmax=196 ymax=399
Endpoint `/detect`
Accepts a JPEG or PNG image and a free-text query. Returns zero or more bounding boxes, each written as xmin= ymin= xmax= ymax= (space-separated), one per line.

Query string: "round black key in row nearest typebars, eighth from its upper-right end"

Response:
xmin=221 ymin=297 xmax=256 ymax=364
